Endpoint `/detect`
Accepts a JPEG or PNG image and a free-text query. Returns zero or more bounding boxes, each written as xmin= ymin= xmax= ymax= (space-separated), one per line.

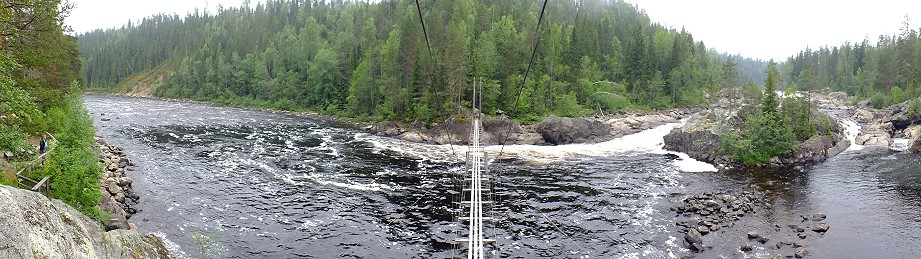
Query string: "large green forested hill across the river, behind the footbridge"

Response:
xmin=77 ymin=0 xmax=766 ymax=122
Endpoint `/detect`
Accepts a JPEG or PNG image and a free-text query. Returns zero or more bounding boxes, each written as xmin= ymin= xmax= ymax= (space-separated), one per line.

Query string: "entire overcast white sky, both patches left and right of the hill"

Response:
xmin=66 ymin=0 xmax=921 ymax=61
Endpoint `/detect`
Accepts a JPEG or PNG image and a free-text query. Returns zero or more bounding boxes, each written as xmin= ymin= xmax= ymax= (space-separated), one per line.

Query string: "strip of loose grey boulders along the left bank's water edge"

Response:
xmin=96 ymin=137 xmax=140 ymax=231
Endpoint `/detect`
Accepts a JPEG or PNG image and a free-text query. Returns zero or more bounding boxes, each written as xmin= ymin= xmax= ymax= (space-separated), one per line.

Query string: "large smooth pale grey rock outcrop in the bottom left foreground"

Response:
xmin=0 ymin=185 xmax=169 ymax=258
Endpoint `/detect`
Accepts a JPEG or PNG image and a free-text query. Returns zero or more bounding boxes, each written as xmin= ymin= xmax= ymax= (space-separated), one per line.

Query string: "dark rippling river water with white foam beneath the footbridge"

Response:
xmin=86 ymin=95 xmax=921 ymax=258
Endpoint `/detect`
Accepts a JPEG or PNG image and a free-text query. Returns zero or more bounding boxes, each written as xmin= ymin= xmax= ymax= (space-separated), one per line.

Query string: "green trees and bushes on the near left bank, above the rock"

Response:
xmin=0 ymin=0 xmax=104 ymax=220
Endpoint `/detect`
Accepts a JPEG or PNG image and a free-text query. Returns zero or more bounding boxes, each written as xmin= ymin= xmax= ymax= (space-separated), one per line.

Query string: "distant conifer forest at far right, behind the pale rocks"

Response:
xmin=782 ymin=16 xmax=921 ymax=108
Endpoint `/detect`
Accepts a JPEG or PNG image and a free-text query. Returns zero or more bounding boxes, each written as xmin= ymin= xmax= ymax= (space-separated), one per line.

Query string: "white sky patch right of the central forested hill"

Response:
xmin=627 ymin=0 xmax=921 ymax=62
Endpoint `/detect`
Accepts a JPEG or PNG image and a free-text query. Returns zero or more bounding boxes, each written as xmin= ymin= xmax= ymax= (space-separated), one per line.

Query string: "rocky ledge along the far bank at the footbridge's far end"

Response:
xmin=366 ymin=108 xmax=693 ymax=145
